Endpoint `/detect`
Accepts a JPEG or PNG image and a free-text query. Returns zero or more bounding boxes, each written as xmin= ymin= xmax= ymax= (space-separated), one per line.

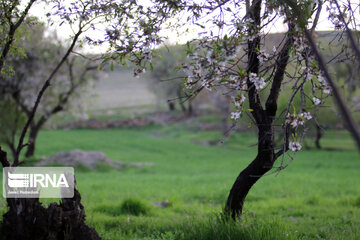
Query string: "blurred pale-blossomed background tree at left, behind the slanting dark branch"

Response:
xmin=0 ymin=23 xmax=98 ymax=158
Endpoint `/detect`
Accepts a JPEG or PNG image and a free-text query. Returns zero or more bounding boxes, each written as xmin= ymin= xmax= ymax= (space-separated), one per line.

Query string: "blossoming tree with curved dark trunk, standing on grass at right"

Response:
xmin=172 ymin=0 xmax=359 ymax=219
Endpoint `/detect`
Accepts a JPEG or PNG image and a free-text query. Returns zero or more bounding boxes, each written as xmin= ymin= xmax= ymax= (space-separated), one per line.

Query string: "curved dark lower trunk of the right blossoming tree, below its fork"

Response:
xmin=225 ymin=125 xmax=275 ymax=219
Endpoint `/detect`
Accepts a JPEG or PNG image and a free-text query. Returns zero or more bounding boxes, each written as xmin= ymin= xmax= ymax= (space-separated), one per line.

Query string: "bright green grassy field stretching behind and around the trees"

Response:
xmin=1 ymin=124 xmax=360 ymax=240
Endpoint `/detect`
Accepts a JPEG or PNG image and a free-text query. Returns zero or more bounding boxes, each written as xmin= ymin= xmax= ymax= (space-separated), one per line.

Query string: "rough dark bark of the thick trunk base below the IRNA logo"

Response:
xmin=0 ymin=148 xmax=101 ymax=240
